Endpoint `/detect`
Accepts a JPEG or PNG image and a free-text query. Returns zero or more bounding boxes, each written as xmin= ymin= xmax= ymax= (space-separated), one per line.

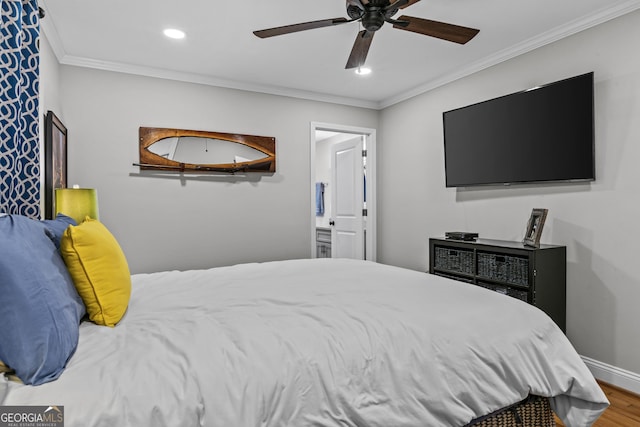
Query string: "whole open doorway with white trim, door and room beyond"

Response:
xmin=310 ymin=123 xmax=376 ymax=261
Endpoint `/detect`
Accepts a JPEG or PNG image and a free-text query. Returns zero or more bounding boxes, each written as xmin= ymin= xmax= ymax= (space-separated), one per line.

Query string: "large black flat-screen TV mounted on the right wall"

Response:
xmin=443 ymin=73 xmax=595 ymax=187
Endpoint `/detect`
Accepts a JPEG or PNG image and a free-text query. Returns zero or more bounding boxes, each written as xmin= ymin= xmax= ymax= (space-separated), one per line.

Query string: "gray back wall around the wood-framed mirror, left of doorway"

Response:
xmin=52 ymin=66 xmax=379 ymax=273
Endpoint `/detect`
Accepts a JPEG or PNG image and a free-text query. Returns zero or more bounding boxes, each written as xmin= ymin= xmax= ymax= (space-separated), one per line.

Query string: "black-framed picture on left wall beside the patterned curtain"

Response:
xmin=44 ymin=111 xmax=68 ymax=219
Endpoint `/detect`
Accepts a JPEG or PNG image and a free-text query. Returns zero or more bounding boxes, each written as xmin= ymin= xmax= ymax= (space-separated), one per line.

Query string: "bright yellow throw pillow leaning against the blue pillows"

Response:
xmin=60 ymin=217 xmax=131 ymax=326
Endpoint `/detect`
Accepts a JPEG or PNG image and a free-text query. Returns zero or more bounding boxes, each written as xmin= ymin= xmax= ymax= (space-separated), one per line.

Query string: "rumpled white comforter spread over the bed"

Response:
xmin=0 ymin=260 xmax=607 ymax=427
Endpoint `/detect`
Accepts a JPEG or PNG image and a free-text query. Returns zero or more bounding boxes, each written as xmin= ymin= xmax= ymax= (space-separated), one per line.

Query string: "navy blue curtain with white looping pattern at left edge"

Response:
xmin=0 ymin=0 xmax=40 ymax=218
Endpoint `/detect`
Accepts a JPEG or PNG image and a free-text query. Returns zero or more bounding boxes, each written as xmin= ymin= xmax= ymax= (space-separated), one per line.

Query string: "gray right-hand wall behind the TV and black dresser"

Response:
xmin=378 ymin=12 xmax=640 ymax=373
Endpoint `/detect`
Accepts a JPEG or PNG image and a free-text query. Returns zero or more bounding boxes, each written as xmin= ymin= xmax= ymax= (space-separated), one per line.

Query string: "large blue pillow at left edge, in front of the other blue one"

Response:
xmin=0 ymin=215 xmax=85 ymax=385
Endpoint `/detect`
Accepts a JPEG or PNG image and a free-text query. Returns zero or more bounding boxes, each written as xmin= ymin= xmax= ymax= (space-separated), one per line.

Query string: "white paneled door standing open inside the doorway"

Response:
xmin=330 ymin=136 xmax=365 ymax=259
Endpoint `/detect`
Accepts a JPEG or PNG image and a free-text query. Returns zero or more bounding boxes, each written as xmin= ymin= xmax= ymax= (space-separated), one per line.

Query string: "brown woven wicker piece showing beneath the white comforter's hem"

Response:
xmin=465 ymin=396 xmax=556 ymax=427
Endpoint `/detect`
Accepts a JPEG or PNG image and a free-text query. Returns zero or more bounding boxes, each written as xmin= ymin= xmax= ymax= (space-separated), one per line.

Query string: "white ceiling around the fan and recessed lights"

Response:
xmin=40 ymin=0 xmax=640 ymax=108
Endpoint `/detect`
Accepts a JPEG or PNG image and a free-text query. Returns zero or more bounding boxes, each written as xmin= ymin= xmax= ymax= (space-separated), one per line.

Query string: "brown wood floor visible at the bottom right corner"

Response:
xmin=556 ymin=381 xmax=640 ymax=427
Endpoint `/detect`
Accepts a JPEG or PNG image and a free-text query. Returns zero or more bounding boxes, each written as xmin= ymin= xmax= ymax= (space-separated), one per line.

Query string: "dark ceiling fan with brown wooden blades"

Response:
xmin=253 ymin=0 xmax=480 ymax=69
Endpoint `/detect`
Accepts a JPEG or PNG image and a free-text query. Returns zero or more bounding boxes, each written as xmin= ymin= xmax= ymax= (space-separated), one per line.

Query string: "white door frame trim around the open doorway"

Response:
xmin=309 ymin=122 xmax=377 ymax=261
